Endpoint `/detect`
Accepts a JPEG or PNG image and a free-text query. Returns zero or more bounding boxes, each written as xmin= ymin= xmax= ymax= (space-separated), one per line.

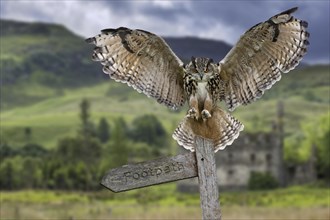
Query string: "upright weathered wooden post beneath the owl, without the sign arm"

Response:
xmin=195 ymin=137 xmax=221 ymax=220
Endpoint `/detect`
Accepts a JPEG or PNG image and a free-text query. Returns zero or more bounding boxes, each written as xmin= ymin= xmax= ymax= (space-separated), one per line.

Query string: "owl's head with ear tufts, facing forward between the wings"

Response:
xmin=185 ymin=57 xmax=216 ymax=82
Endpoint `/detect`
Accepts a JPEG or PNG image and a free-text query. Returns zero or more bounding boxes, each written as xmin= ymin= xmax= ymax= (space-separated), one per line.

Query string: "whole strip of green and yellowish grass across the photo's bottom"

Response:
xmin=0 ymin=183 xmax=330 ymax=219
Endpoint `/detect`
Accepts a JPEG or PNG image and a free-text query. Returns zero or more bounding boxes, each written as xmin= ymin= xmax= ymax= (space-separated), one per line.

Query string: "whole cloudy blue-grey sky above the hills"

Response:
xmin=0 ymin=0 xmax=330 ymax=63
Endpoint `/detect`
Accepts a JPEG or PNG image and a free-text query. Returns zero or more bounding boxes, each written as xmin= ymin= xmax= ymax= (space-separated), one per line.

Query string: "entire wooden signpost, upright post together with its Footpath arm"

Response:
xmin=101 ymin=137 xmax=221 ymax=220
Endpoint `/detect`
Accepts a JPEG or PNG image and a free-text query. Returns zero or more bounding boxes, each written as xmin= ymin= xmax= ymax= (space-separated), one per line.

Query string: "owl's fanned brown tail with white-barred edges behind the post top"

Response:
xmin=172 ymin=107 xmax=244 ymax=152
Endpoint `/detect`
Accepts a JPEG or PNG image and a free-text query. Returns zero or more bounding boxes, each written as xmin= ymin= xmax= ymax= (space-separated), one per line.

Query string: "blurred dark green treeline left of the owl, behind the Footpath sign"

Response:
xmin=0 ymin=99 xmax=168 ymax=191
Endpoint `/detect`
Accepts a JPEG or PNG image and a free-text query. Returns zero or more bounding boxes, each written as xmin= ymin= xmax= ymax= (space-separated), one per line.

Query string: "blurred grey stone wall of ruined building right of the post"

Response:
xmin=216 ymin=133 xmax=283 ymax=188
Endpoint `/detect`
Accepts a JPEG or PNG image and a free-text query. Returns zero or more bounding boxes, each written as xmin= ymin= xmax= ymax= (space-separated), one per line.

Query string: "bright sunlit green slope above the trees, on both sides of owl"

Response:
xmin=1 ymin=66 xmax=329 ymax=147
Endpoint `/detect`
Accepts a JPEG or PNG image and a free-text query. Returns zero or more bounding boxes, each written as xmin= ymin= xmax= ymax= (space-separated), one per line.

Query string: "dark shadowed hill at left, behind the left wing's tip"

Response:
xmin=0 ymin=20 xmax=105 ymax=109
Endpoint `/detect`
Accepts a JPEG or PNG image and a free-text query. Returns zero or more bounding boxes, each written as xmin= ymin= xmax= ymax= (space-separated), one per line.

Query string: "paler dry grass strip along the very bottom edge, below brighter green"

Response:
xmin=1 ymin=202 xmax=329 ymax=220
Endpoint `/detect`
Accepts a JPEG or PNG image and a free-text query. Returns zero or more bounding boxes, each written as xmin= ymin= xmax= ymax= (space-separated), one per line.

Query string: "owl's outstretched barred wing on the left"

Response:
xmin=86 ymin=27 xmax=186 ymax=109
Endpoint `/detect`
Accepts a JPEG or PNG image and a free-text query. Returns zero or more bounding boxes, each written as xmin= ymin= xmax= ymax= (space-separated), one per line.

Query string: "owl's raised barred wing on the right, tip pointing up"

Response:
xmin=218 ymin=8 xmax=309 ymax=111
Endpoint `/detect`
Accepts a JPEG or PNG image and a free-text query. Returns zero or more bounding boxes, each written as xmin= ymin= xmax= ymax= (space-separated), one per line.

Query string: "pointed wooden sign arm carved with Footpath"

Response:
xmin=101 ymin=152 xmax=197 ymax=192
